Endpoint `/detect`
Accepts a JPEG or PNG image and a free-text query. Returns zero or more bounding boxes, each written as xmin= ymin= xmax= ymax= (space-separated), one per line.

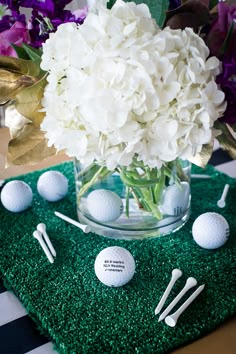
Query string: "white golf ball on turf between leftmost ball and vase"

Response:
xmin=37 ymin=171 xmax=68 ymax=202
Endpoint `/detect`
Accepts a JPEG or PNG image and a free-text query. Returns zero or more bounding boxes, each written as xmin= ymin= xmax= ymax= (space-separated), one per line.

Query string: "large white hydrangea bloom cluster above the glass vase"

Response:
xmin=41 ymin=0 xmax=225 ymax=169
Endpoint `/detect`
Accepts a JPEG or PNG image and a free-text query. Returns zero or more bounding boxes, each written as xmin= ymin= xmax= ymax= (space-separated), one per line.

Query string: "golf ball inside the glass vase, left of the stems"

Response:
xmin=87 ymin=189 xmax=123 ymax=222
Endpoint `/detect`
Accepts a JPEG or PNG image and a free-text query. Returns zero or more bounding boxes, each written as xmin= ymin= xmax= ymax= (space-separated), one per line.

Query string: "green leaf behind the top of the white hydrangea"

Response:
xmin=108 ymin=0 xmax=169 ymax=27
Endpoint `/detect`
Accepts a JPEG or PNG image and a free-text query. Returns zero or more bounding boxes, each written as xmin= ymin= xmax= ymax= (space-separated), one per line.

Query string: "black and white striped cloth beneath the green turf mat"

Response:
xmin=0 ymin=146 xmax=236 ymax=354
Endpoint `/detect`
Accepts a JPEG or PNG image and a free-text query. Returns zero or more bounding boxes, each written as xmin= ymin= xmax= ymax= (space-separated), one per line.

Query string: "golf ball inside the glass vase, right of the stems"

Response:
xmin=161 ymin=182 xmax=190 ymax=216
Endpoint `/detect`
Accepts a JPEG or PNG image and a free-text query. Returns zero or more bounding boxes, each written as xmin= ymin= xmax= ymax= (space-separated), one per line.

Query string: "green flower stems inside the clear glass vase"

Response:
xmin=77 ymin=161 xmax=187 ymax=220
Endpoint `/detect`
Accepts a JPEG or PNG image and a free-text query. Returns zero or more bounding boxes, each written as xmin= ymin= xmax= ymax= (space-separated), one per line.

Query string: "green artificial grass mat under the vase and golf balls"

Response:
xmin=0 ymin=162 xmax=236 ymax=354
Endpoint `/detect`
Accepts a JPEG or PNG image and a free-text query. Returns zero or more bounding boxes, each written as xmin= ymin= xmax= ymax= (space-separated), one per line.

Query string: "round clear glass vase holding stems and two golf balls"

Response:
xmin=74 ymin=159 xmax=191 ymax=239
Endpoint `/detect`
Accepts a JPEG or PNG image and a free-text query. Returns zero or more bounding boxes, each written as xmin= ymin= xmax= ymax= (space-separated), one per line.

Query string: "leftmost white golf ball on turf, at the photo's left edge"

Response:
xmin=1 ymin=181 xmax=33 ymax=213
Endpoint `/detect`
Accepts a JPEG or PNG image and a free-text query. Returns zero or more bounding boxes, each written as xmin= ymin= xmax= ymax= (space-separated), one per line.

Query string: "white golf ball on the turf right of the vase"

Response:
xmin=192 ymin=212 xmax=229 ymax=249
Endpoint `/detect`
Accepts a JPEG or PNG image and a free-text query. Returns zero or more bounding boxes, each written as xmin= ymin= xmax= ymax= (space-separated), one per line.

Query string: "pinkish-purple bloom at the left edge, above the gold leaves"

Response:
xmin=0 ymin=21 xmax=29 ymax=57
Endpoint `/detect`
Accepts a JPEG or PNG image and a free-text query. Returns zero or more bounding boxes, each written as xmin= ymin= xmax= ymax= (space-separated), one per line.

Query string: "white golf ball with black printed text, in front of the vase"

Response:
xmin=94 ymin=246 xmax=135 ymax=287
